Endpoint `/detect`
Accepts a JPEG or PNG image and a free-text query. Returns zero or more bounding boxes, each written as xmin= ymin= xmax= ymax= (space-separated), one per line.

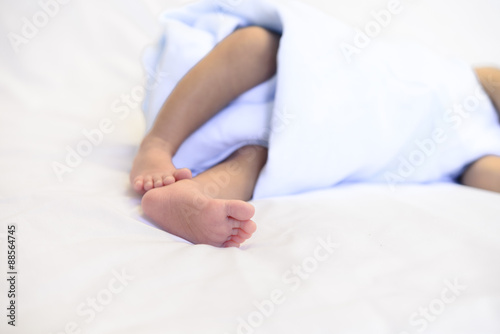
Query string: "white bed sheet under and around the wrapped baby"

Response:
xmin=0 ymin=0 xmax=500 ymax=334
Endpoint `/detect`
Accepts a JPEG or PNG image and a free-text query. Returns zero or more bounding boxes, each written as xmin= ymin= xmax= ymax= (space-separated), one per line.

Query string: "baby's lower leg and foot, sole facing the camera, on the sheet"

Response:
xmin=142 ymin=146 xmax=267 ymax=247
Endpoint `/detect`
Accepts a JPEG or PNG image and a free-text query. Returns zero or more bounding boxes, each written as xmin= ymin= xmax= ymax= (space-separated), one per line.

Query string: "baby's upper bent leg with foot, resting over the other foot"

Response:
xmin=130 ymin=27 xmax=280 ymax=193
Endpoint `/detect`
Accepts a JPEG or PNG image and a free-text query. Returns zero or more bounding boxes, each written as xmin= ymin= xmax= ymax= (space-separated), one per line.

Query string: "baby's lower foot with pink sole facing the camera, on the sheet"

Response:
xmin=142 ymin=180 xmax=257 ymax=247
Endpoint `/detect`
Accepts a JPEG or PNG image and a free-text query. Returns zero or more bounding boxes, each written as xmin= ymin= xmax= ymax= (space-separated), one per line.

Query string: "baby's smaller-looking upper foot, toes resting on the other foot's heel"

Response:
xmin=130 ymin=138 xmax=191 ymax=194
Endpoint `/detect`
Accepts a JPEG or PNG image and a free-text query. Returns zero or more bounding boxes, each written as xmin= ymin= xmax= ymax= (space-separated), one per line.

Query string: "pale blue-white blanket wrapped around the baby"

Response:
xmin=146 ymin=0 xmax=500 ymax=198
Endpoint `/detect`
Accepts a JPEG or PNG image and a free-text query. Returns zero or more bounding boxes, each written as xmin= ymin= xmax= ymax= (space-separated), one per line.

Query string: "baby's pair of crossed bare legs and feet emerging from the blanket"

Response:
xmin=130 ymin=27 xmax=280 ymax=247
